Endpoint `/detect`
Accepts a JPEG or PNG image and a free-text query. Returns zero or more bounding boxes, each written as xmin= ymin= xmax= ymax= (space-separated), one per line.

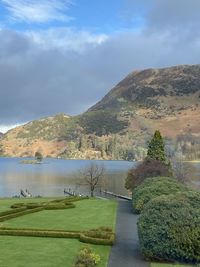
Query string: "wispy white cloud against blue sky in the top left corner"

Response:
xmin=2 ymin=0 xmax=73 ymax=23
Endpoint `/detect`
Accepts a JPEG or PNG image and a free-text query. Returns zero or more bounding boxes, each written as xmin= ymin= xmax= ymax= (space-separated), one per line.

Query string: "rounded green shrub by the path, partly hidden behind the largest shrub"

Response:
xmin=133 ymin=177 xmax=187 ymax=213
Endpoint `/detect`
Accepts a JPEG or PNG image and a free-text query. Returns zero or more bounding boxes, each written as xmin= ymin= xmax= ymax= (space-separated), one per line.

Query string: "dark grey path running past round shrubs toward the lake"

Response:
xmin=108 ymin=200 xmax=149 ymax=267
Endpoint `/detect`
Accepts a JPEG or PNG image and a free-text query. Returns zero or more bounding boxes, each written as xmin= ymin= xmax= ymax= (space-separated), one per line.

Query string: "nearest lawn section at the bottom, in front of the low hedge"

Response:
xmin=0 ymin=236 xmax=110 ymax=267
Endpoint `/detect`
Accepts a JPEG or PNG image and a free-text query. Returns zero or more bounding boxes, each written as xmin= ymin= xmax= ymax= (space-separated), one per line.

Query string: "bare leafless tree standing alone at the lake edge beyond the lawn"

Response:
xmin=80 ymin=163 xmax=105 ymax=197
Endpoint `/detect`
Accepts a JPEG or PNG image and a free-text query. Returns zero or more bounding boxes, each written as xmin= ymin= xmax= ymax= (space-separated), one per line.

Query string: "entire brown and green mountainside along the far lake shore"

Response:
xmin=0 ymin=65 xmax=200 ymax=160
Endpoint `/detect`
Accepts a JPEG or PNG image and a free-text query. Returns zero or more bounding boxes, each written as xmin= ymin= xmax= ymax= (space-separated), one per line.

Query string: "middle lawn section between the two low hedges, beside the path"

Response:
xmin=2 ymin=199 xmax=117 ymax=230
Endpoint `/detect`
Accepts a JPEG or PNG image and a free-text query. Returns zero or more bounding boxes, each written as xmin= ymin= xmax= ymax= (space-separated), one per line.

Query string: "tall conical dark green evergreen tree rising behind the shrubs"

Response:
xmin=147 ymin=130 xmax=167 ymax=162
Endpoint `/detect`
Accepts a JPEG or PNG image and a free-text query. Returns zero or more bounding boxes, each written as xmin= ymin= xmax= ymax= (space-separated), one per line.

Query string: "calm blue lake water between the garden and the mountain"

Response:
xmin=0 ymin=158 xmax=200 ymax=197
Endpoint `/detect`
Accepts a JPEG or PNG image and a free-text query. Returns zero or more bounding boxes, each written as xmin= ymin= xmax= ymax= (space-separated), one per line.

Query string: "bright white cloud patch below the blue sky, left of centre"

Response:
xmin=25 ymin=28 xmax=108 ymax=53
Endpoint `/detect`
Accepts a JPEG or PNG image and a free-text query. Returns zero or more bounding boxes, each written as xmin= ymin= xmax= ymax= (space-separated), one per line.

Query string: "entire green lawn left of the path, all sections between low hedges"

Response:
xmin=0 ymin=199 xmax=117 ymax=267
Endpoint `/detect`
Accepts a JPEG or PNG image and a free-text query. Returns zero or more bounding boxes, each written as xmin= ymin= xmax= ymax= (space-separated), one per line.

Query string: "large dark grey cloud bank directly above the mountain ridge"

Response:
xmin=0 ymin=22 xmax=200 ymax=124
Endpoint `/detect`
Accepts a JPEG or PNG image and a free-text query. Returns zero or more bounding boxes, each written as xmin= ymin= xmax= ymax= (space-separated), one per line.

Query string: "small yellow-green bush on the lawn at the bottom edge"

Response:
xmin=74 ymin=247 xmax=101 ymax=267
